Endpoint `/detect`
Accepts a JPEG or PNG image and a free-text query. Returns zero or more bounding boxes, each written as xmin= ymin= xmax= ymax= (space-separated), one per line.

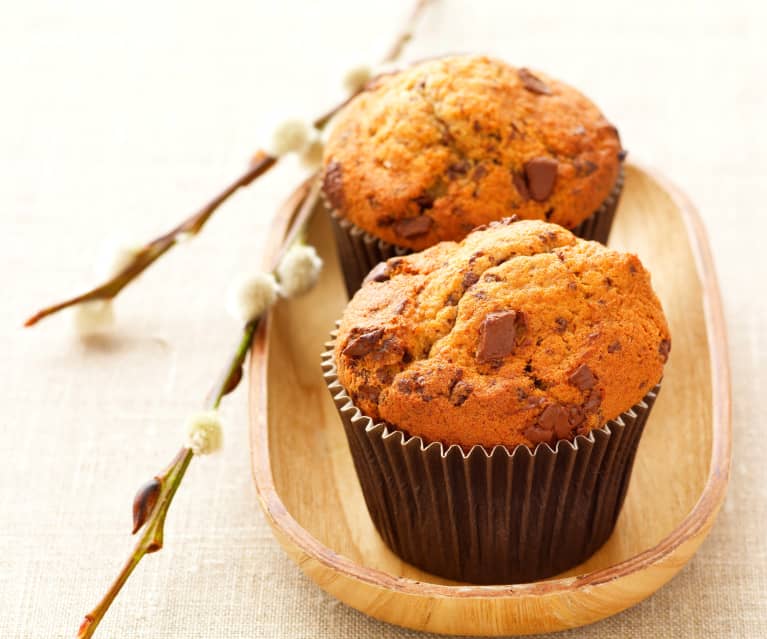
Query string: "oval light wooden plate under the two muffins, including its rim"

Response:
xmin=250 ymin=165 xmax=730 ymax=635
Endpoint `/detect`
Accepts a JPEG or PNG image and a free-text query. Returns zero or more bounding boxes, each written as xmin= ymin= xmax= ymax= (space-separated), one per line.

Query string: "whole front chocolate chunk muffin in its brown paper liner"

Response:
xmin=324 ymin=220 xmax=671 ymax=583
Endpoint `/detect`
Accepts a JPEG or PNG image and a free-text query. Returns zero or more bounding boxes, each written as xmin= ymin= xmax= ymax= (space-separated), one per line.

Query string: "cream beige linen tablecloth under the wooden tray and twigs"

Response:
xmin=0 ymin=0 xmax=767 ymax=639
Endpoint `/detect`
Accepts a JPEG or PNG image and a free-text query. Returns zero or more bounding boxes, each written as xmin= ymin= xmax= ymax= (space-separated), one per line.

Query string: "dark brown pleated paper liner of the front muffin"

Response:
xmin=322 ymin=333 xmax=660 ymax=584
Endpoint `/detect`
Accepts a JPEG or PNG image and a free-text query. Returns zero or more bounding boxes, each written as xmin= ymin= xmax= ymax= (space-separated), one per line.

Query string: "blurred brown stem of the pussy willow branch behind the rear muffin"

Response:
xmin=24 ymin=0 xmax=430 ymax=327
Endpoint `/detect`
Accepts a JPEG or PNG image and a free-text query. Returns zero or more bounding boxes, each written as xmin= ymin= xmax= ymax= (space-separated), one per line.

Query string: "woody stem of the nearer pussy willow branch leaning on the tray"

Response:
xmin=77 ymin=176 xmax=319 ymax=639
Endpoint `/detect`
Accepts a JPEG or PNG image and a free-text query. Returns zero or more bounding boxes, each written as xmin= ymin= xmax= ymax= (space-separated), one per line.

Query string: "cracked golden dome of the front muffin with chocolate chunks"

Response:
xmin=334 ymin=219 xmax=671 ymax=448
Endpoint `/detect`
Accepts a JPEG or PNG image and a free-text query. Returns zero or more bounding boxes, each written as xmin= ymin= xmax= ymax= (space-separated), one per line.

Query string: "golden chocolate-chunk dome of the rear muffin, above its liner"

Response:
xmin=323 ymin=56 xmax=624 ymax=250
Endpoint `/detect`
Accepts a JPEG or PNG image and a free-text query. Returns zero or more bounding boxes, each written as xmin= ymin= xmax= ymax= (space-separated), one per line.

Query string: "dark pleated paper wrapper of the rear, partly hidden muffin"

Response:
xmin=325 ymin=168 xmax=623 ymax=297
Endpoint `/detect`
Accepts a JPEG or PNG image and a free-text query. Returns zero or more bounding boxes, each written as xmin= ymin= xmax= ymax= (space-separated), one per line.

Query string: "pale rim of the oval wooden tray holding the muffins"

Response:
xmin=249 ymin=161 xmax=732 ymax=604
